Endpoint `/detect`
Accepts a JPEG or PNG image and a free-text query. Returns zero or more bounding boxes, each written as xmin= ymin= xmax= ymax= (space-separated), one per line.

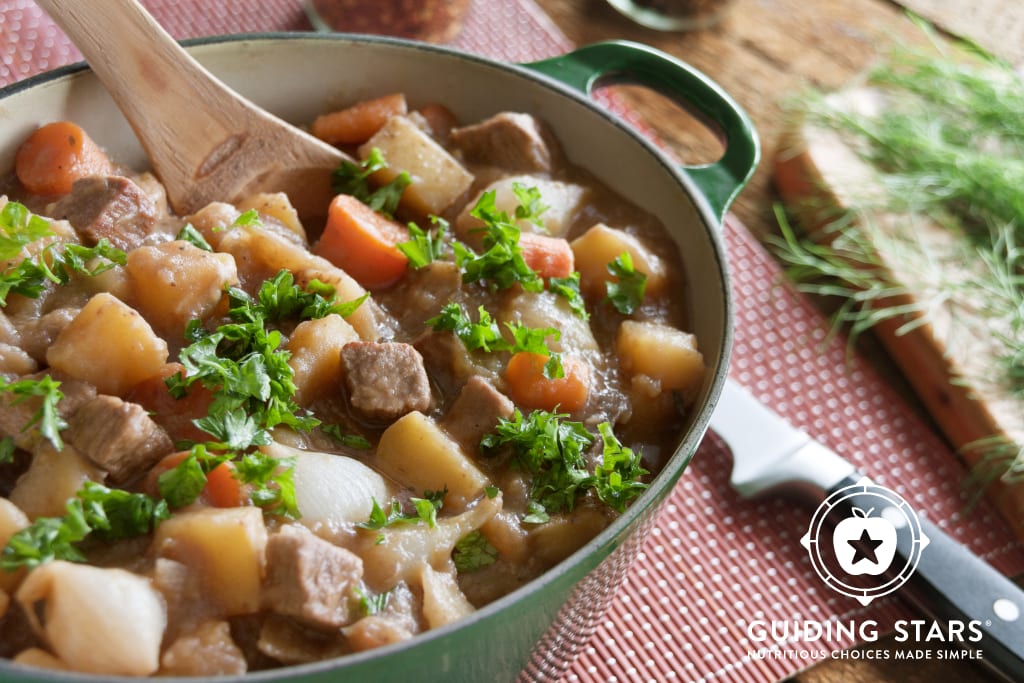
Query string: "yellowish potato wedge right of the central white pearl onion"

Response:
xmin=377 ymin=411 xmax=490 ymax=509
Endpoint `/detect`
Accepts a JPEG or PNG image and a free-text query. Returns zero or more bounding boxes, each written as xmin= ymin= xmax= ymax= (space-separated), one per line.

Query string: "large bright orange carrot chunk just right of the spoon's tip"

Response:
xmin=313 ymin=195 xmax=409 ymax=289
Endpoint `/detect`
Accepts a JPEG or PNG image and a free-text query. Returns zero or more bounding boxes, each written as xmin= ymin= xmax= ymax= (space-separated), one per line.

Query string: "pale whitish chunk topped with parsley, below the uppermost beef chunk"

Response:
xmin=455 ymin=175 xmax=587 ymax=239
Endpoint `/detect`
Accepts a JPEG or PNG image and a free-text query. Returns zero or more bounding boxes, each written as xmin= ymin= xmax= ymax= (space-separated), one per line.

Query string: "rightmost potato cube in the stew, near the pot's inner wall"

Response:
xmin=615 ymin=321 xmax=705 ymax=394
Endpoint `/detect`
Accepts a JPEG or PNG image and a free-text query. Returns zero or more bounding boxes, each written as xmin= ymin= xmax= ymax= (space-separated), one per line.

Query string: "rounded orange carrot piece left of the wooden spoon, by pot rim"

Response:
xmin=14 ymin=121 xmax=113 ymax=195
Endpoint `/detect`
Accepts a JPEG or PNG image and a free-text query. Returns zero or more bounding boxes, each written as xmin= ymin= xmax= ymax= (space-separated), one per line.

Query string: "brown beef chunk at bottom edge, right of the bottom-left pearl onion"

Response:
xmin=160 ymin=621 xmax=248 ymax=676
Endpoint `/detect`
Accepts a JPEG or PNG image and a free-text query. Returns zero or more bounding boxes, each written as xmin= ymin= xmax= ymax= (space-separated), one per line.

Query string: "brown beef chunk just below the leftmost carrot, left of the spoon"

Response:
xmin=50 ymin=175 xmax=157 ymax=251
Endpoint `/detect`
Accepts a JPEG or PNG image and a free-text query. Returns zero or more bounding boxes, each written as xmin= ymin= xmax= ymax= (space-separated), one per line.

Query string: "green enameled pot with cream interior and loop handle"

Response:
xmin=0 ymin=34 xmax=759 ymax=683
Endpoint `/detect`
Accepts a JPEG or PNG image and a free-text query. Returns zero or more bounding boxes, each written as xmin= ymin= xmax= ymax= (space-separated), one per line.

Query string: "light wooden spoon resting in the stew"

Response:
xmin=38 ymin=0 xmax=346 ymax=217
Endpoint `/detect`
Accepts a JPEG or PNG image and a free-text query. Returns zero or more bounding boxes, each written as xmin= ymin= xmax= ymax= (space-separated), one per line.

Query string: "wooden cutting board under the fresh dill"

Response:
xmin=772 ymin=88 xmax=1024 ymax=539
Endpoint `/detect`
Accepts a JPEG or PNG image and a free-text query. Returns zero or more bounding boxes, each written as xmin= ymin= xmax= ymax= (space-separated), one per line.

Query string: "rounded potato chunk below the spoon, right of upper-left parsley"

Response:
xmin=126 ymin=241 xmax=239 ymax=338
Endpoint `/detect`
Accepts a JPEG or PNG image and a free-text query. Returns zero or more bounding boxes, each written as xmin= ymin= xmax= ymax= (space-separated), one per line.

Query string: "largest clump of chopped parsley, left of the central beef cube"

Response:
xmin=159 ymin=270 xmax=366 ymax=518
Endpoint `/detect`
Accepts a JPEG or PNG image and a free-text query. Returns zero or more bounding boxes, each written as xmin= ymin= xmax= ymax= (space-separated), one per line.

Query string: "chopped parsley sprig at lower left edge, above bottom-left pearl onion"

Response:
xmin=0 ymin=481 xmax=170 ymax=571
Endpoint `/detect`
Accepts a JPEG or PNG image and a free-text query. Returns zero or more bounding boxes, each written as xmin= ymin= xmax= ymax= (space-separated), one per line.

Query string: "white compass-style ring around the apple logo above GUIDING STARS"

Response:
xmin=800 ymin=477 xmax=930 ymax=606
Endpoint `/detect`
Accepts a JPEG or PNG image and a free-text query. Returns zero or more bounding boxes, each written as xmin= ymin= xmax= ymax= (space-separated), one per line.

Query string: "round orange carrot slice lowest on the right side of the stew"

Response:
xmin=505 ymin=351 xmax=590 ymax=413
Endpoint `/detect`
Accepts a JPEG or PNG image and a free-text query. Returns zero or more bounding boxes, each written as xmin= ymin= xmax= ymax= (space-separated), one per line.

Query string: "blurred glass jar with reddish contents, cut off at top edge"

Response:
xmin=304 ymin=0 xmax=470 ymax=43
